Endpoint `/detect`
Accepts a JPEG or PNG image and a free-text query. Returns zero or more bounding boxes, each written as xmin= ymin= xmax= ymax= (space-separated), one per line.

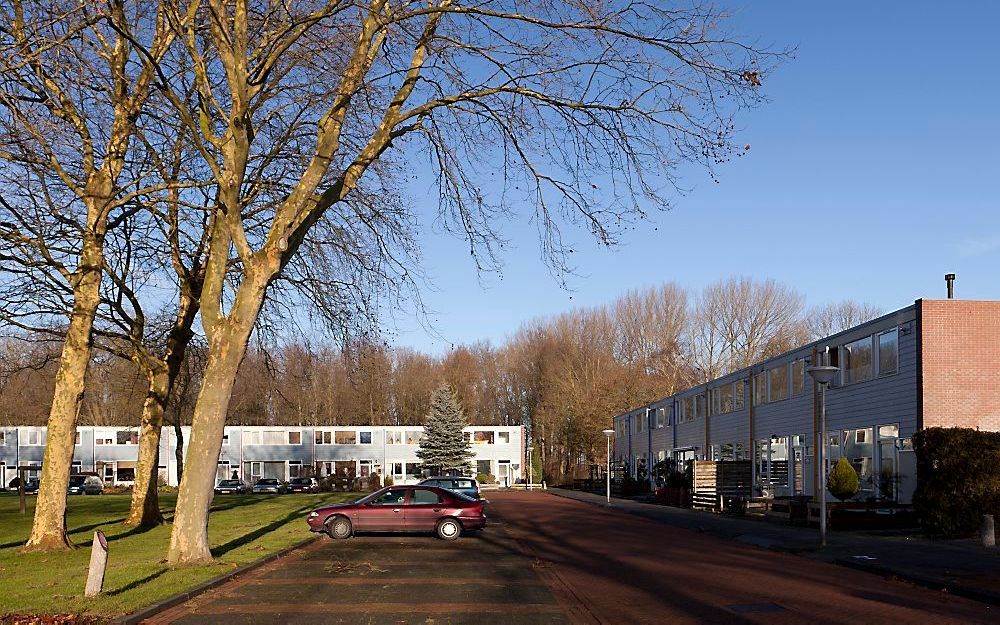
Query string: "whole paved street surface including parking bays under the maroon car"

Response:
xmin=150 ymin=492 xmax=998 ymax=625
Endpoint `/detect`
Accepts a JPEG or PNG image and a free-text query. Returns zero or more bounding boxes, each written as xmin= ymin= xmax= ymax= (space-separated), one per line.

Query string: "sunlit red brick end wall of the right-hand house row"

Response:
xmin=918 ymin=299 xmax=1000 ymax=431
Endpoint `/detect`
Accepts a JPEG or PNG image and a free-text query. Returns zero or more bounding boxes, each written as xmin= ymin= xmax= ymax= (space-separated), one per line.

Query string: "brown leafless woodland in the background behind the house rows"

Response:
xmin=0 ymin=278 xmax=880 ymax=480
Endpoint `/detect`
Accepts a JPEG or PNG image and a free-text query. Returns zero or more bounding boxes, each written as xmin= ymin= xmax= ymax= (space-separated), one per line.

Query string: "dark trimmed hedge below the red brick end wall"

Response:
xmin=913 ymin=428 xmax=1000 ymax=536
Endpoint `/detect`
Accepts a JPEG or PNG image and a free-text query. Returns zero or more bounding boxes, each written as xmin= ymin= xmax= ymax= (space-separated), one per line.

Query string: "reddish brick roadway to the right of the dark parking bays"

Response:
xmin=491 ymin=493 xmax=1000 ymax=625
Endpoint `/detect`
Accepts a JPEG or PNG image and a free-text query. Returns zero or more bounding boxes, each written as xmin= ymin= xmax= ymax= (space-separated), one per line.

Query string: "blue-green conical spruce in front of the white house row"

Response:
xmin=417 ymin=384 xmax=475 ymax=475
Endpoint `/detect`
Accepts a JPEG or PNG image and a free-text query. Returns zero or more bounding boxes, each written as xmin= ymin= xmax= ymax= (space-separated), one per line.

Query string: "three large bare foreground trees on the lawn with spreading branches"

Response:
xmin=0 ymin=0 xmax=785 ymax=564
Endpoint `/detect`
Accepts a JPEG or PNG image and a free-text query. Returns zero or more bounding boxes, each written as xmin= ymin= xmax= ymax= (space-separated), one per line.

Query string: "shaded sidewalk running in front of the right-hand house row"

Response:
xmin=548 ymin=488 xmax=1000 ymax=605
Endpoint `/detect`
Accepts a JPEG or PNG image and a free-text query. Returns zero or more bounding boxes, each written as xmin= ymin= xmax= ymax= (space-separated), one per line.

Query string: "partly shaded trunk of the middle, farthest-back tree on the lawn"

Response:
xmin=125 ymin=369 xmax=170 ymax=527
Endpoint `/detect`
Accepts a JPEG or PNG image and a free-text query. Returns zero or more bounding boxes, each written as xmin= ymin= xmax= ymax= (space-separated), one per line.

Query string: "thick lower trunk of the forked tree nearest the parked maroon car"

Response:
xmin=167 ymin=294 xmax=265 ymax=565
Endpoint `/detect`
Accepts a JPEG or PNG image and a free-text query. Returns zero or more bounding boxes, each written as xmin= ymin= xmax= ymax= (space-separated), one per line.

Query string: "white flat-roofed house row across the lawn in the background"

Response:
xmin=0 ymin=426 xmax=525 ymax=486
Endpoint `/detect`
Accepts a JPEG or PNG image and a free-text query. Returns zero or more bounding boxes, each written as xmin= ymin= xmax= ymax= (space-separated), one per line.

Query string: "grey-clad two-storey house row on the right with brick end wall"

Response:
xmin=614 ymin=299 xmax=1000 ymax=503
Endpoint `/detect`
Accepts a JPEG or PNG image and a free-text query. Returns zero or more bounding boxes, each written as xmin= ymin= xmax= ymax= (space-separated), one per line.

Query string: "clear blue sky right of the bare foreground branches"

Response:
xmin=386 ymin=1 xmax=1000 ymax=354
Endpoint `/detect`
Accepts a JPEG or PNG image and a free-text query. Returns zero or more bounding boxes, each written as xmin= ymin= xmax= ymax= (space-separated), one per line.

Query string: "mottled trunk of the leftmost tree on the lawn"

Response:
xmin=24 ymin=235 xmax=103 ymax=551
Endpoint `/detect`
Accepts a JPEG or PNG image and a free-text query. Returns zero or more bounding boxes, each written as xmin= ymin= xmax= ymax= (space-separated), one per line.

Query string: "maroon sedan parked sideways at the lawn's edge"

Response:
xmin=306 ymin=486 xmax=486 ymax=540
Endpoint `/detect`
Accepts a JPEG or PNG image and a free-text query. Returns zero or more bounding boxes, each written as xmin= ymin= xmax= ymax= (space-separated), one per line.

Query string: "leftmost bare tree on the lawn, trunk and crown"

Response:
xmin=0 ymin=0 xmax=174 ymax=550
